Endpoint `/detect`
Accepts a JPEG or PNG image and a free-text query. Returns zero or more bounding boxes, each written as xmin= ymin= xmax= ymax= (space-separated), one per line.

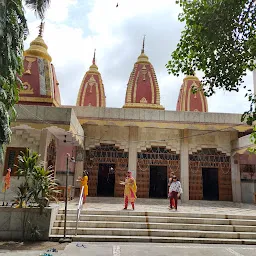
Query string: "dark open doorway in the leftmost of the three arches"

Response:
xmin=97 ymin=164 xmax=115 ymax=196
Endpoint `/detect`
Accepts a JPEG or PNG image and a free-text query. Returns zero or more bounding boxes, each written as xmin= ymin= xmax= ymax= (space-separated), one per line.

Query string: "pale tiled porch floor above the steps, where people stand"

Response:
xmin=59 ymin=197 xmax=256 ymax=216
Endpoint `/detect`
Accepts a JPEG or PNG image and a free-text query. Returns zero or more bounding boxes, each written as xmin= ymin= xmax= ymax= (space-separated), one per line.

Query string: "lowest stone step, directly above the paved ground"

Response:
xmin=50 ymin=235 xmax=256 ymax=245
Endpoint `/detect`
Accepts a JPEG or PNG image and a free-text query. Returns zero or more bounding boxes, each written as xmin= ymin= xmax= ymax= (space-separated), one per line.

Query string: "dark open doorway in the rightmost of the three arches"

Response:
xmin=202 ymin=168 xmax=219 ymax=200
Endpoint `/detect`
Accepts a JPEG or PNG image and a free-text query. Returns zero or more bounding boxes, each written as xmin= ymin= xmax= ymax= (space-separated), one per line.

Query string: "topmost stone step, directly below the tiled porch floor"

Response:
xmin=59 ymin=210 xmax=256 ymax=220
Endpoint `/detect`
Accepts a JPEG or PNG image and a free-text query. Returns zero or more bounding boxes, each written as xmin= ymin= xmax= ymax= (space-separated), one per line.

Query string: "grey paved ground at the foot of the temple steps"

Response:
xmin=0 ymin=243 xmax=256 ymax=256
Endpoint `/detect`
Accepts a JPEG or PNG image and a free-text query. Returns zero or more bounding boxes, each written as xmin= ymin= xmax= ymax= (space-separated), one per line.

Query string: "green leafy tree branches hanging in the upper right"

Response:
xmin=166 ymin=0 xmax=256 ymax=124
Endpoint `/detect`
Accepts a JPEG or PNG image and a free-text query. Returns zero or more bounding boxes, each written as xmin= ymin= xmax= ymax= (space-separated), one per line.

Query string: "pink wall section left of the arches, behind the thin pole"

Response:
xmin=56 ymin=145 xmax=76 ymax=172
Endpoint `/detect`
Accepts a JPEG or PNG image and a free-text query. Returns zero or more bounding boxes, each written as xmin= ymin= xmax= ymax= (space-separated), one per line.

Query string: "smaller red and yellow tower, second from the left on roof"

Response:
xmin=76 ymin=51 xmax=106 ymax=107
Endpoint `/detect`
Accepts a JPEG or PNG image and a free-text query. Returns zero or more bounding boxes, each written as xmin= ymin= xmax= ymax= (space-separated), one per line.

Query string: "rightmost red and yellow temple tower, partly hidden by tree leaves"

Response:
xmin=176 ymin=76 xmax=208 ymax=112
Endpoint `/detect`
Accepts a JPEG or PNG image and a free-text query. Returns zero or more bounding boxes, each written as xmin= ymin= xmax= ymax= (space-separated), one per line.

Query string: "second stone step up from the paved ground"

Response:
xmin=52 ymin=227 xmax=256 ymax=241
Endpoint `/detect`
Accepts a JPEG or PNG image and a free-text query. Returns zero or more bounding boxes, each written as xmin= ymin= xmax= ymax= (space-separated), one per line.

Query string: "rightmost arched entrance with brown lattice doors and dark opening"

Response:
xmin=189 ymin=148 xmax=232 ymax=201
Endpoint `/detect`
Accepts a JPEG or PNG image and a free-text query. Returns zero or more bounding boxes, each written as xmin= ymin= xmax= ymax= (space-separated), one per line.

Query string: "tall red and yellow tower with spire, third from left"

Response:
xmin=123 ymin=37 xmax=164 ymax=109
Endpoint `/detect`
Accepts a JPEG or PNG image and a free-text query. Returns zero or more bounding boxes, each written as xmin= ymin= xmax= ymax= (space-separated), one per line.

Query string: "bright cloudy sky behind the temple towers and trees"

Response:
xmin=25 ymin=0 xmax=253 ymax=113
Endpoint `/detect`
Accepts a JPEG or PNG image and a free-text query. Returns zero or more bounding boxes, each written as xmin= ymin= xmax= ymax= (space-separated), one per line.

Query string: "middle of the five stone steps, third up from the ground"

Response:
xmin=54 ymin=221 xmax=256 ymax=232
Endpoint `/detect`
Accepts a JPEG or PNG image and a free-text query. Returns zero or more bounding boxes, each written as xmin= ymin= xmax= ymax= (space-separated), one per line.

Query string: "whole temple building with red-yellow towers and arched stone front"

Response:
xmin=0 ymin=27 xmax=256 ymax=203
